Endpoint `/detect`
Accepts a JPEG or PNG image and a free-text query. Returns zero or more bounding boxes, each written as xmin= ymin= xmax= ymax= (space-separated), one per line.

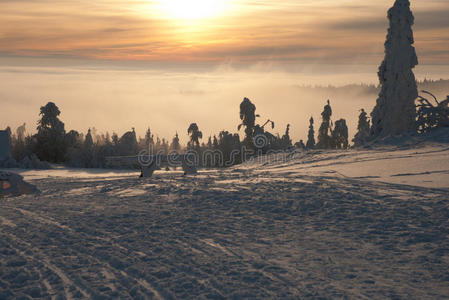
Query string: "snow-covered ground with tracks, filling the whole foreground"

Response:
xmin=0 ymin=144 xmax=449 ymax=299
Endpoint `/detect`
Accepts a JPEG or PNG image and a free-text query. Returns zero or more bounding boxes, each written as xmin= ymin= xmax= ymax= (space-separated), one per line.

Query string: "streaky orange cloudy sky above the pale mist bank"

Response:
xmin=0 ymin=0 xmax=449 ymax=64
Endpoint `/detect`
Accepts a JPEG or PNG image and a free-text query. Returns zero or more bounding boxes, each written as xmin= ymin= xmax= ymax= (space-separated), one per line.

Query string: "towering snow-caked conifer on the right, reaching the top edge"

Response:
xmin=371 ymin=0 xmax=418 ymax=138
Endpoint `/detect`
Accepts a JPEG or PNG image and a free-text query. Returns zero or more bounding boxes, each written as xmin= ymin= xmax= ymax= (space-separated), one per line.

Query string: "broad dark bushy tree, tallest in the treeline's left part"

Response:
xmin=36 ymin=102 xmax=65 ymax=162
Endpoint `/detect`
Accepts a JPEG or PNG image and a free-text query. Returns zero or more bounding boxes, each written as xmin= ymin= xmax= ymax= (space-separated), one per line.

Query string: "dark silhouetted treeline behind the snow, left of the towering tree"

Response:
xmin=0 ymin=98 xmax=349 ymax=168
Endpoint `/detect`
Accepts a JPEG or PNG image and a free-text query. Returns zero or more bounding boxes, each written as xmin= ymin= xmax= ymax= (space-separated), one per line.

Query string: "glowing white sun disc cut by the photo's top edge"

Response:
xmin=160 ymin=0 xmax=226 ymax=20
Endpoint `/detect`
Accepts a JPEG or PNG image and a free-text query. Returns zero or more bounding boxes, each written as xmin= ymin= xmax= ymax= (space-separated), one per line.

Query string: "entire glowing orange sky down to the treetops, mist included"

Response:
xmin=0 ymin=0 xmax=449 ymax=141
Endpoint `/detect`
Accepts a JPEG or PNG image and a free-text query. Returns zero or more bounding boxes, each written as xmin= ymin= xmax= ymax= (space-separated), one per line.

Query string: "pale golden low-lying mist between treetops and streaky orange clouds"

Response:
xmin=0 ymin=66 xmax=449 ymax=142
